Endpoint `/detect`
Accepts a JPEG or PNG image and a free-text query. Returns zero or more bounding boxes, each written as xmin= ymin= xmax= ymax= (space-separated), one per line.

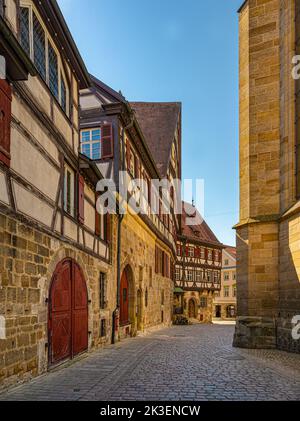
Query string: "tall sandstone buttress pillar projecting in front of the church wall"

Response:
xmin=234 ymin=0 xmax=280 ymax=348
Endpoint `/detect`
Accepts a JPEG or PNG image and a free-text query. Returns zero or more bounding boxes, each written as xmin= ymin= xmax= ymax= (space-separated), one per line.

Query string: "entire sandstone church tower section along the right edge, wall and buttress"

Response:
xmin=234 ymin=0 xmax=300 ymax=352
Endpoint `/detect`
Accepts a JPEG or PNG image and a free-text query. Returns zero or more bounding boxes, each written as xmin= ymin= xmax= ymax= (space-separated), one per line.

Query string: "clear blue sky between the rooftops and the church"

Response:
xmin=58 ymin=0 xmax=242 ymax=245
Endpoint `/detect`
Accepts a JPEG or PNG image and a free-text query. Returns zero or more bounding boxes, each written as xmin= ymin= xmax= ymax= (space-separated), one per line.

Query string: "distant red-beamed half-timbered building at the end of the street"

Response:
xmin=174 ymin=202 xmax=223 ymax=323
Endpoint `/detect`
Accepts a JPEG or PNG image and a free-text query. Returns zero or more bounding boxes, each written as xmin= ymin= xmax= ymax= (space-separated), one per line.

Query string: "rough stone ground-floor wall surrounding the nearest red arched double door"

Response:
xmin=0 ymin=214 xmax=115 ymax=387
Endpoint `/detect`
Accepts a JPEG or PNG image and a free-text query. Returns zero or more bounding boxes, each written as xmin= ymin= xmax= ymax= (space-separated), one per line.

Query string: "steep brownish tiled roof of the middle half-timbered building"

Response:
xmin=130 ymin=102 xmax=181 ymax=177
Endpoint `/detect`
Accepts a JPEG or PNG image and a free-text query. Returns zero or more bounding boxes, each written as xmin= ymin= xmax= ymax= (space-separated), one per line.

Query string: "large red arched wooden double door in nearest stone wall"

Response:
xmin=48 ymin=259 xmax=88 ymax=364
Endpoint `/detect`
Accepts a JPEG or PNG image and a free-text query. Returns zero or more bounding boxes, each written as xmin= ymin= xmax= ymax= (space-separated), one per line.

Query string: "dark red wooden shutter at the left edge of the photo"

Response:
xmin=0 ymin=79 xmax=11 ymax=167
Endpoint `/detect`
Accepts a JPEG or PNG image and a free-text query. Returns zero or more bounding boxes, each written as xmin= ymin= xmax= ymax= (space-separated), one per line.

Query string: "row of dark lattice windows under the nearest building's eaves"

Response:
xmin=19 ymin=5 xmax=69 ymax=115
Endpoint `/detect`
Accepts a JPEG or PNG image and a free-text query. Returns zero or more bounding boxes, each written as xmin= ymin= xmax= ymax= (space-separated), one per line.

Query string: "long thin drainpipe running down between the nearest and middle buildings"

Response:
xmin=111 ymin=109 xmax=134 ymax=344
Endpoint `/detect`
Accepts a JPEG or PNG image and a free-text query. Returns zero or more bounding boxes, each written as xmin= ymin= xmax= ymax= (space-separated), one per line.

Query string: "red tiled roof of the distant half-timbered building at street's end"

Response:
xmin=181 ymin=202 xmax=222 ymax=245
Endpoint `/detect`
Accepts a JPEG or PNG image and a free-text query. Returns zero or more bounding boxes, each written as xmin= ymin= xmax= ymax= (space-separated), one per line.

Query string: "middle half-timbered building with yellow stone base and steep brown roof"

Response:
xmin=80 ymin=77 xmax=181 ymax=337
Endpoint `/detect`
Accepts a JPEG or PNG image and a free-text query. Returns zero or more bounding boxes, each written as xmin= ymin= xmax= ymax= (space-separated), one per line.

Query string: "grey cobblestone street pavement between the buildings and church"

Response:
xmin=0 ymin=325 xmax=300 ymax=401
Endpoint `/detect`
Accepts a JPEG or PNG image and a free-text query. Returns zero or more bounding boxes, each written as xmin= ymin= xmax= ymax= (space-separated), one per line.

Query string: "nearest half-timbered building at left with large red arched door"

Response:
xmin=0 ymin=0 xmax=115 ymax=386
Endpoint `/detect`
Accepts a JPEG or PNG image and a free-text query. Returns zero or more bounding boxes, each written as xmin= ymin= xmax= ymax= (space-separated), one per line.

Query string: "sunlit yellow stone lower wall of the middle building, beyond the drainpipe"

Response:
xmin=120 ymin=214 xmax=174 ymax=336
